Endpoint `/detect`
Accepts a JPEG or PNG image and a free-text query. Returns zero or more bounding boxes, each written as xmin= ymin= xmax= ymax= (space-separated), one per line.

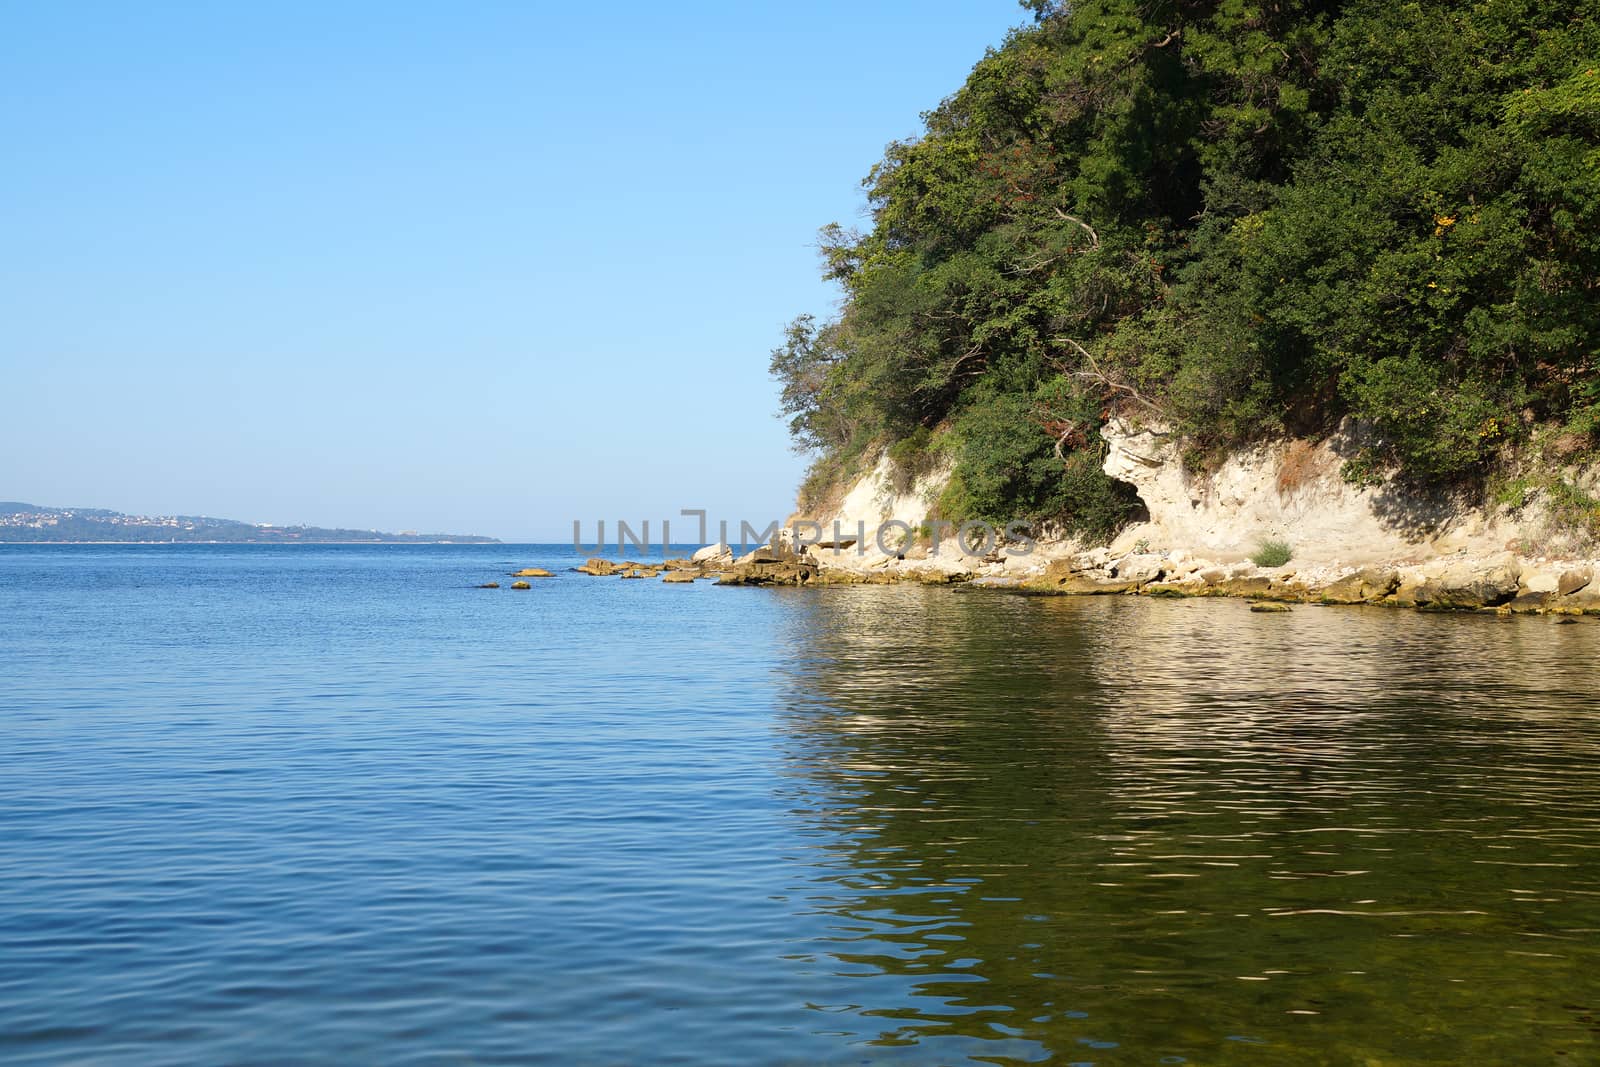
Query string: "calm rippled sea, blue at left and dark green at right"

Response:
xmin=0 ymin=545 xmax=1600 ymax=1065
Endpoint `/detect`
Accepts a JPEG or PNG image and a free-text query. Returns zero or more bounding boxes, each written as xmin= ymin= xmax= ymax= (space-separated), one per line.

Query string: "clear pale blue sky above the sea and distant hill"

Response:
xmin=0 ymin=0 xmax=1027 ymax=541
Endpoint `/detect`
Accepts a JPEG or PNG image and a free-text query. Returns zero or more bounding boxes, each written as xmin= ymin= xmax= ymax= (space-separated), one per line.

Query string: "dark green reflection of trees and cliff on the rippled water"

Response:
xmin=768 ymin=589 xmax=1600 ymax=1062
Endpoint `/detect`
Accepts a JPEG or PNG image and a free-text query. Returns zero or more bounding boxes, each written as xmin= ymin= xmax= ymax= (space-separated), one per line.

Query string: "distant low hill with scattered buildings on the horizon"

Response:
xmin=0 ymin=501 xmax=499 ymax=544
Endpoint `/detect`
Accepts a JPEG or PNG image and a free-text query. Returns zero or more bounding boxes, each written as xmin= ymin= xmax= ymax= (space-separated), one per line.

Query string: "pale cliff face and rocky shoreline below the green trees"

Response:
xmin=528 ymin=418 xmax=1600 ymax=616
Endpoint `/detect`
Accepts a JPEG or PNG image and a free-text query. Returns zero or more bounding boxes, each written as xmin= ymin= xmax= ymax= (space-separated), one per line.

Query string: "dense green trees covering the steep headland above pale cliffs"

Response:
xmin=773 ymin=0 xmax=1600 ymax=533
